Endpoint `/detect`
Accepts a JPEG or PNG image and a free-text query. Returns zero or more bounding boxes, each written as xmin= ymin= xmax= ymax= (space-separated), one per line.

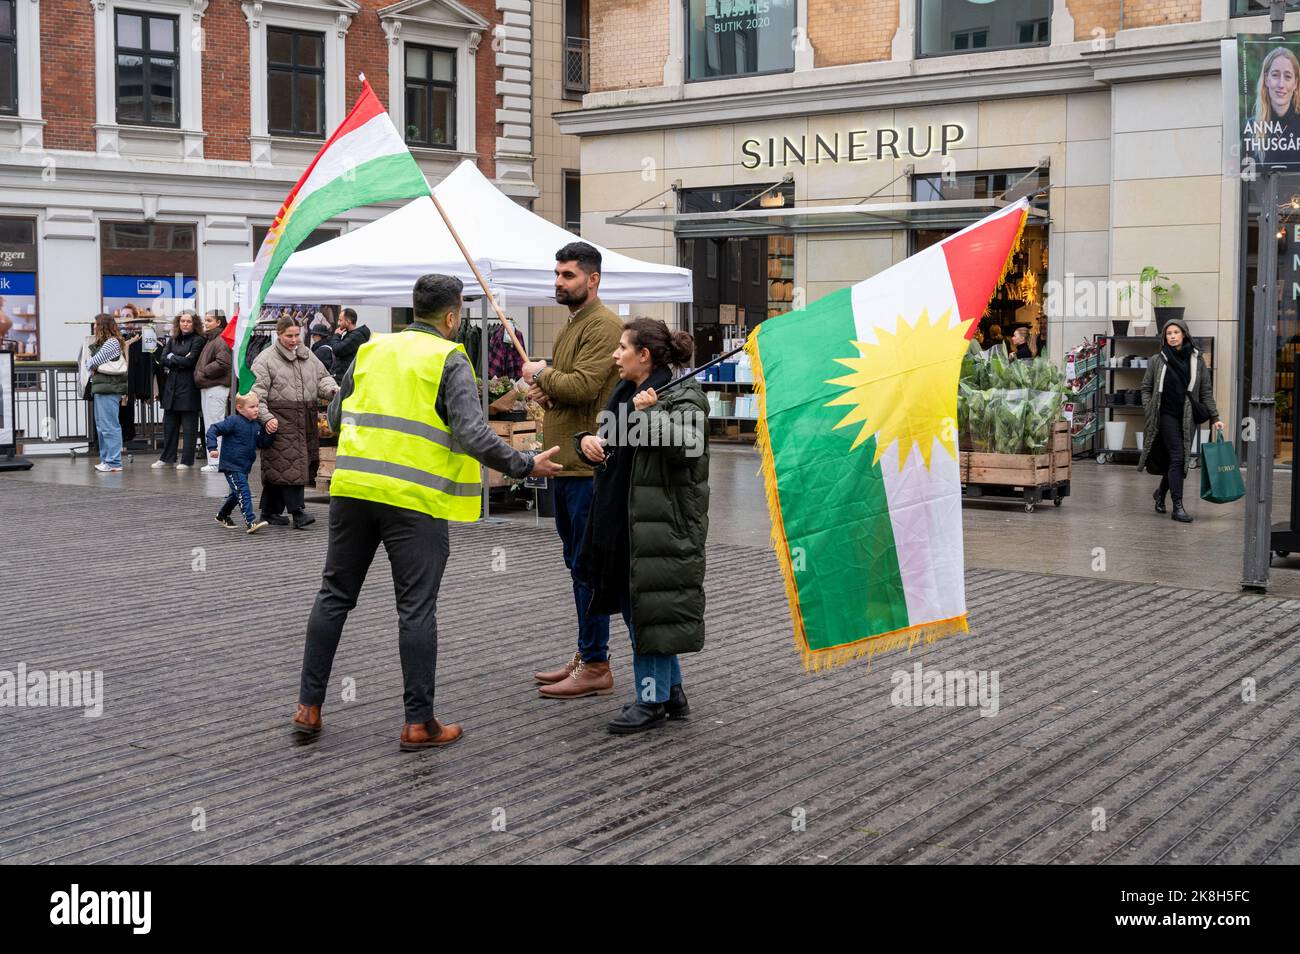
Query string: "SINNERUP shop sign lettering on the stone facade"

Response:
xmin=740 ymin=122 xmax=966 ymax=169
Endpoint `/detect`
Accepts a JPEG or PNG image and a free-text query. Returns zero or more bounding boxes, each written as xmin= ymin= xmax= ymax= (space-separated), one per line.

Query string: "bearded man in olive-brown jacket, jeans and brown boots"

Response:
xmin=524 ymin=242 xmax=623 ymax=699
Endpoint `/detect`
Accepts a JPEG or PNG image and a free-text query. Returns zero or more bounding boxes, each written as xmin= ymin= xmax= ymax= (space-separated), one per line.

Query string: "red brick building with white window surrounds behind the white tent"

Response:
xmin=0 ymin=0 xmax=576 ymax=360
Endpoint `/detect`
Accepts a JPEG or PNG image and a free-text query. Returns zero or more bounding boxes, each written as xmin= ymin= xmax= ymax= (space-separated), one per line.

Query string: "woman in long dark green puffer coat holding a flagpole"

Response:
xmin=573 ymin=318 xmax=709 ymax=734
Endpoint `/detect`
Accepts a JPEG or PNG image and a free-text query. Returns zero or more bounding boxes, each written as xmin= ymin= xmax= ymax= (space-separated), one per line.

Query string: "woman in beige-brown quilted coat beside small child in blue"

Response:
xmin=252 ymin=317 xmax=338 ymax=530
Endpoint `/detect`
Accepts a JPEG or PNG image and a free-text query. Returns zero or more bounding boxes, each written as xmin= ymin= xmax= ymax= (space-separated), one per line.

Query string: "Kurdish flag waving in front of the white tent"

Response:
xmin=226 ymin=77 xmax=429 ymax=394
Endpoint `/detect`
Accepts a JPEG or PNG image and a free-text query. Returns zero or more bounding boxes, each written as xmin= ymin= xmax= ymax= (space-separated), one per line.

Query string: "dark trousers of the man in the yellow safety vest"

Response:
xmin=298 ymin=496 xmax=451 ymax=723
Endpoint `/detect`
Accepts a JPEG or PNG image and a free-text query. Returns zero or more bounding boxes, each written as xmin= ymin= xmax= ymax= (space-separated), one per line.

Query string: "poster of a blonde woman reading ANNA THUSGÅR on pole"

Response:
xmin=1240 ymin=40 xmax=1300 ymax=166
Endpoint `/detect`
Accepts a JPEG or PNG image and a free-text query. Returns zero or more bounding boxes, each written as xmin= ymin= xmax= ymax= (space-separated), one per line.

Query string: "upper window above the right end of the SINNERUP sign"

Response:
xmin=917 ymin=0 xmax=1052 ymax=56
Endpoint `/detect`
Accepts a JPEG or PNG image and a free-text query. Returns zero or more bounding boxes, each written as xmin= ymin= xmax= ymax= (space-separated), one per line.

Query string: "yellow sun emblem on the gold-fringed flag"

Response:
xmin=827 ymin=309 xmax=970 ymax=471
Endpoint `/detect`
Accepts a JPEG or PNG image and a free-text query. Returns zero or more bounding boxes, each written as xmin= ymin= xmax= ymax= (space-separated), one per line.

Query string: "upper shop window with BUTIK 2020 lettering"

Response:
xmin=683 ymin=0 xmax=797 ymax=79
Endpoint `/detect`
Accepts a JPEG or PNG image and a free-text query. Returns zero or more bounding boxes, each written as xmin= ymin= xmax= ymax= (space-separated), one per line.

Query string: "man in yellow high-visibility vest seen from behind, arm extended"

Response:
xmin=293 ymin=274 xmax=560 ymax=751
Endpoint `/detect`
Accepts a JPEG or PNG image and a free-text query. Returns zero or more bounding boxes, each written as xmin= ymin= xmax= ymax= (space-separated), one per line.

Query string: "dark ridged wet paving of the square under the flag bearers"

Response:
xmin=0 ymin=470 xmax=1300 ymax=863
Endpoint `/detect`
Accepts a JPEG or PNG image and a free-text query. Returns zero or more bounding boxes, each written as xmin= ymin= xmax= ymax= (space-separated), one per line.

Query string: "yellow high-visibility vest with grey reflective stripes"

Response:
xmin=330 ymin=331 xmax=482 ymax=521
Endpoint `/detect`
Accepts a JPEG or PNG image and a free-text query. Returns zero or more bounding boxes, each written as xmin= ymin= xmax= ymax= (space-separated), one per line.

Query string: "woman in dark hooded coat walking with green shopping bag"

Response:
xmin=1138 ymin=318 xmax=1223 ymax=524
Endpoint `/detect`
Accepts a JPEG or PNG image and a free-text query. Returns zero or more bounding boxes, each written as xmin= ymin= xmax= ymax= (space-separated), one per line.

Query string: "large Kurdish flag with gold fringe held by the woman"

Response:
xmin=746 ymin=200 xmax=1028 ymax=669
